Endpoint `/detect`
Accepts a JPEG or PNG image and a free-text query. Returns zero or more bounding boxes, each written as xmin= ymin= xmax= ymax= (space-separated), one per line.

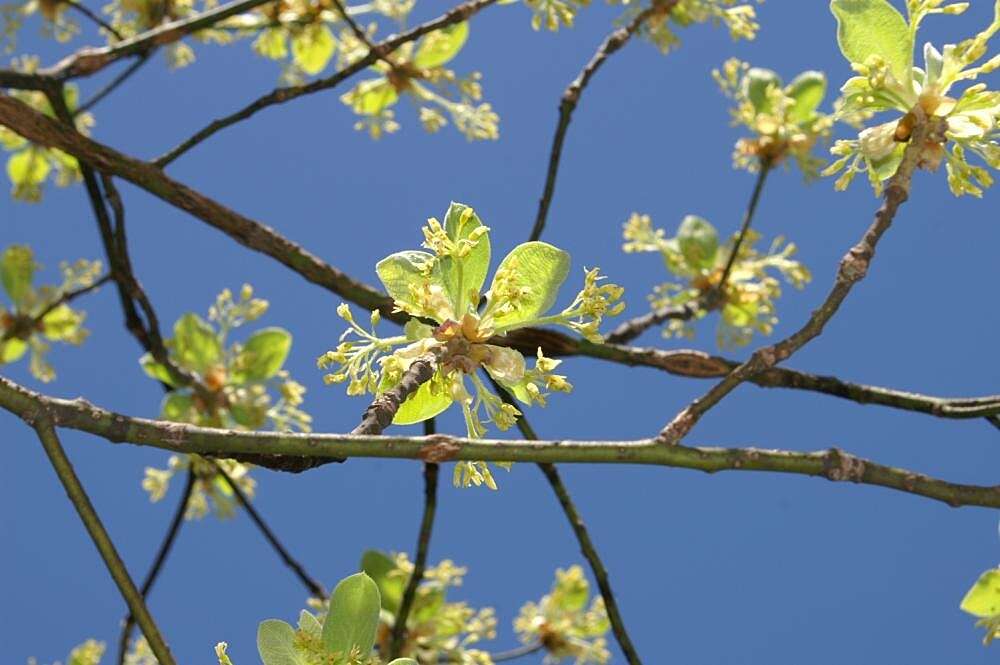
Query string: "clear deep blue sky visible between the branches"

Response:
xmin=0 ymin=0 xmax=1000 ymax=665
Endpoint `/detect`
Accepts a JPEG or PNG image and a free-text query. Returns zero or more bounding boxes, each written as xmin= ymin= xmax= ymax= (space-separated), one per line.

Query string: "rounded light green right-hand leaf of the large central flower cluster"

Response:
xmin=490 ymin=241 xmax=570 ymax=328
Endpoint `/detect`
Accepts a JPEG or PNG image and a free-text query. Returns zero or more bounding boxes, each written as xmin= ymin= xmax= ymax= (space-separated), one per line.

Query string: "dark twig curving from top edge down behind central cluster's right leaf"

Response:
xmin=529 ymin=0 xmax=679 ymax=240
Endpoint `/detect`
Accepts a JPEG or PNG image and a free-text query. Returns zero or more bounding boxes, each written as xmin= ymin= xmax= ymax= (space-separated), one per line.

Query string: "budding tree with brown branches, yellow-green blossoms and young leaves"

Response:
xmin=0 ymin=0 xmax=1000 ymax=665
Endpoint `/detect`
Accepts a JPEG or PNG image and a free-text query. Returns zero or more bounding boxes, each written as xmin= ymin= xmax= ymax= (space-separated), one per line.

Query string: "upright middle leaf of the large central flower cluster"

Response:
xmin=439 ymin=201 xmax=491 ymax=318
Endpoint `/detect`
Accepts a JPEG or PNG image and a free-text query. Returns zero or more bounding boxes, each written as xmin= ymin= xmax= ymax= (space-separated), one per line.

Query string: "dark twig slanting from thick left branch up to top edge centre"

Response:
xmin=152 ymin=0 xmax=497 ymax=168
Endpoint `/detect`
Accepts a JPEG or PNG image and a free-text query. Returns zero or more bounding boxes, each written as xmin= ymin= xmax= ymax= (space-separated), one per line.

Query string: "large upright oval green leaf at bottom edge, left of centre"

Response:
xmin=323 ymin=573 xmax=381 ymax=660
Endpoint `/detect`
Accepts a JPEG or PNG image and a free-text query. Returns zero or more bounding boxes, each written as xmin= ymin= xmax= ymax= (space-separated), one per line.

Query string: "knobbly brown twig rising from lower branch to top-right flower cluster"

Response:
xmin=659 ymin=111 xmax=937 ymax=445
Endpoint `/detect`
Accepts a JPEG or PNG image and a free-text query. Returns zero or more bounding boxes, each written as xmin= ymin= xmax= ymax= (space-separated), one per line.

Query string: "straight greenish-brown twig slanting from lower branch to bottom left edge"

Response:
xmin=33 ymin=416 xmax=176 ymax=665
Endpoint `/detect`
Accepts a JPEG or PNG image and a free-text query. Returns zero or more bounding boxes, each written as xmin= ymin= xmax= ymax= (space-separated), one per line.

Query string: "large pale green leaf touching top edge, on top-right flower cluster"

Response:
xmin=830 ymin=0 xmax=913 ymax=83
